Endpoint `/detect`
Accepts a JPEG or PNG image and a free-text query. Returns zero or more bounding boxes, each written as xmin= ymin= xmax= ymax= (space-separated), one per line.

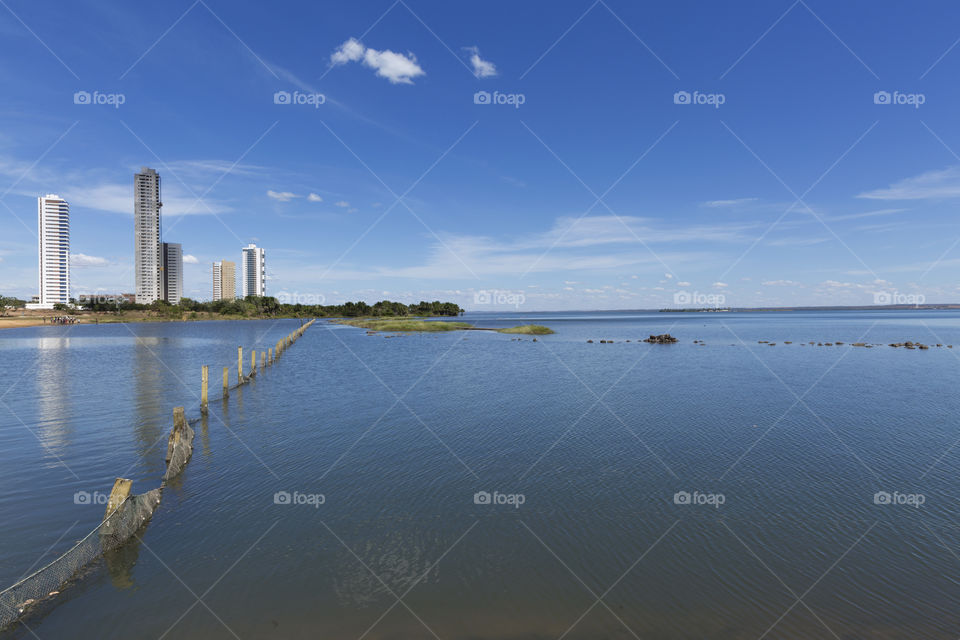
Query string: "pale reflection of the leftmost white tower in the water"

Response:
xmin=32 ymin=336 xmax=71 ymax=455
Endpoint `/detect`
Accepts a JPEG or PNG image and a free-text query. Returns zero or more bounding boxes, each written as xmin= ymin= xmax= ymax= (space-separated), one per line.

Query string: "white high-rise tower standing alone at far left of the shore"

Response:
xmin=37 ymin=193 xmax=70 ymax=309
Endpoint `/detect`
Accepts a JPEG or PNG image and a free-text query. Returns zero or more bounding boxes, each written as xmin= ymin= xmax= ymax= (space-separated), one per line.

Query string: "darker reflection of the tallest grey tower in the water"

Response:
xmin=133 ymin=336 xmax=169 ymax=475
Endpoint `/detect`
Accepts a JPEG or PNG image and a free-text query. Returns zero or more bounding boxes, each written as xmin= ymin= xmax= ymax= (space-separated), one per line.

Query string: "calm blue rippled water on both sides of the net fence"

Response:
xmin=0 ymin=311 xmax=960 ymax=640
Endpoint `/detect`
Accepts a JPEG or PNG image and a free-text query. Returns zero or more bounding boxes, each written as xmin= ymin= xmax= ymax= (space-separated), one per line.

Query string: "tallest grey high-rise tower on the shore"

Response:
xmin=133 ymin=167 xmax=164 ymax=304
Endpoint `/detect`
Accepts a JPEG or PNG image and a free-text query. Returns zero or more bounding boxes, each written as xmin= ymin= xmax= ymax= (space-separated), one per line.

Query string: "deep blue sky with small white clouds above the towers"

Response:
xmin=0 ymin=0 xmax=960 ymax=310
